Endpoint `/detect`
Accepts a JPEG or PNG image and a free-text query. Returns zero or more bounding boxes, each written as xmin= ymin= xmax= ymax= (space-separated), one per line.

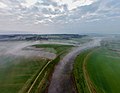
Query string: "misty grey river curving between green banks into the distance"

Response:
xmin=48 ymin=40 xmax=100 ymax=93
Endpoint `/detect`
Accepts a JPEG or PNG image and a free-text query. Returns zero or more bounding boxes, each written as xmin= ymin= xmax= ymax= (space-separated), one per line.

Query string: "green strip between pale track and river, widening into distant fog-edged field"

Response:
xmin=28 ymin=44 xmax=73 ymax=93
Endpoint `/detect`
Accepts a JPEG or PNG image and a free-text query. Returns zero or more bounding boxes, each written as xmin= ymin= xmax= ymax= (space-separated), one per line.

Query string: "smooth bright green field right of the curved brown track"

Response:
xmin=87 ymin=48 xmax=120 ymax=93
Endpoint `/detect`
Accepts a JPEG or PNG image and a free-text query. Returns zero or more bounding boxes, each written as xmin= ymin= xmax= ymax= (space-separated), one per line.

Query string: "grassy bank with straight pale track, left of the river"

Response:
xmin=19 ymin=55 xmax=60 ymax=93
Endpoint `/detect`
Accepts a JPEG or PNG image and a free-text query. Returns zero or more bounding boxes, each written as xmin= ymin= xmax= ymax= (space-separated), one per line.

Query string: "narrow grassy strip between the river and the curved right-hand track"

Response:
xmin=73 ymin=51 xmax=90 ymax=93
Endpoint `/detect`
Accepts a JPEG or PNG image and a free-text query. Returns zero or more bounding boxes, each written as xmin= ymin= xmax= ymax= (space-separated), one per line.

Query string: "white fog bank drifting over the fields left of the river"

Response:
xmin=0 ymin=41 xmax=56 ymax=59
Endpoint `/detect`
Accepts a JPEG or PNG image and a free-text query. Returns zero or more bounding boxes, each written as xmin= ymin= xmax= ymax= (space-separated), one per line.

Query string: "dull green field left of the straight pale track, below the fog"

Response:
xmin=0 ymin=56 xmax=47 ymax=93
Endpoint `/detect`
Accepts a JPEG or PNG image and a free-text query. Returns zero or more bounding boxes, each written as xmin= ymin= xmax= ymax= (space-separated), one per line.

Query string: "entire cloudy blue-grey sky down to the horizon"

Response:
xmin=0 ymin=0 xmax=120 ymax=34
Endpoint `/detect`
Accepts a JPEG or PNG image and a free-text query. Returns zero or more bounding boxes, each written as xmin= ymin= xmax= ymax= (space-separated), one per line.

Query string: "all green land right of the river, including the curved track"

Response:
xmin=73 ymin=40 xmax=120 ymax=93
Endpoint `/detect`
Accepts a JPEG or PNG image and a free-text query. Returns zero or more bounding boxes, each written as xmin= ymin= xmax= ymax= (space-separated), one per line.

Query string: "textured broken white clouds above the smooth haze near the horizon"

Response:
xmin=0 ymin=0 xmax=120 ymax=33
